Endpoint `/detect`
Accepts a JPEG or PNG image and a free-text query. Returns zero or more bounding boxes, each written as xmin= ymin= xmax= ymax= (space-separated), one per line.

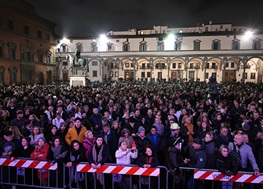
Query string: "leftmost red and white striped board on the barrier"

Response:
xmin=0 ymin=158 xmax=57 ymax=170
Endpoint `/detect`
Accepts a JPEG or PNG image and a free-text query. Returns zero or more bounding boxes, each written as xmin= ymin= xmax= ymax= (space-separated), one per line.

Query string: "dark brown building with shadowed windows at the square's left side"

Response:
xmin=0 ymin=0 xmax=56 ymax=85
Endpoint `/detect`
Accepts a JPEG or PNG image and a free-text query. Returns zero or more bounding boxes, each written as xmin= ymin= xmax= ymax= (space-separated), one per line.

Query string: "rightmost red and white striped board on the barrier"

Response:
xmin=194 ymin=170 xmax=263 ymax=184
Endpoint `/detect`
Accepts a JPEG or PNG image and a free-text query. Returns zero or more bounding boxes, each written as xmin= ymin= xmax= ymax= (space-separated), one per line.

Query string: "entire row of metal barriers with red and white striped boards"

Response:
xmin=0 ymin=158 xmax=263 ymax=189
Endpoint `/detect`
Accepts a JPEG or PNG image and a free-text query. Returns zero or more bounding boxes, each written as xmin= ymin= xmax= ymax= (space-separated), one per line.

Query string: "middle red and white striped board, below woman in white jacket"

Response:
xmin=77 ymin=164 xmax=160 ymax=177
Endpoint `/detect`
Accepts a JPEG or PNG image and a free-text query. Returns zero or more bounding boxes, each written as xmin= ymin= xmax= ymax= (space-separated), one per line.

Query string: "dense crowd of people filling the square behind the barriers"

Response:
xmin=0 ymin=81 xmax=263 ymax=188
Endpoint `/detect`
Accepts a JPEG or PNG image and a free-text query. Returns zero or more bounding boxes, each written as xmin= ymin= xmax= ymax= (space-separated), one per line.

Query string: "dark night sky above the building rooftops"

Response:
xmin=27 ymin=0 xmax=263 ymax=37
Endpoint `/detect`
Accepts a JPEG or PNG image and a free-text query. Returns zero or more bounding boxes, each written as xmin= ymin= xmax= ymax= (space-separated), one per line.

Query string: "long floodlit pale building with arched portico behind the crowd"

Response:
xmin=56 ymin=22 xmax=263 ymax=83
